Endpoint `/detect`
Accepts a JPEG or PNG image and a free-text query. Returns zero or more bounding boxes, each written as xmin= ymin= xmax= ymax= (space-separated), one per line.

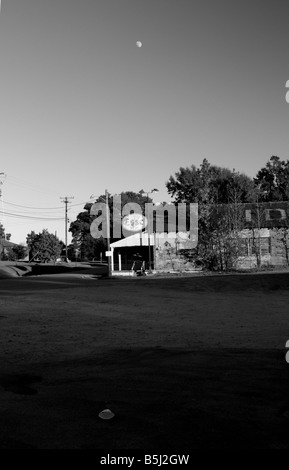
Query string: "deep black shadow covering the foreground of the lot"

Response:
xmin=0 ymin=348 xmax=289 ymax=451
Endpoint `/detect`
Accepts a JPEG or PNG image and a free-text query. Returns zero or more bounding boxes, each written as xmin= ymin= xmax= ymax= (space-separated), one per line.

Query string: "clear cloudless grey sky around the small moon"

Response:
xmin=0 ymin=0 xmax=289 ymax=243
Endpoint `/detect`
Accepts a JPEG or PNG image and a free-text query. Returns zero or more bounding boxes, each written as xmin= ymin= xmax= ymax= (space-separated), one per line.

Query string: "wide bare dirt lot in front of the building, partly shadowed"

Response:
xmin=0 ymin=273 xmax=289 ymax=451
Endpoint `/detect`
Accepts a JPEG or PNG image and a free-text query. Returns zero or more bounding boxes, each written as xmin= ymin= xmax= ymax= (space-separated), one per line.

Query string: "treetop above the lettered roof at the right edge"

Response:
xmin=254 ymin=155 xmax=289 ymax=202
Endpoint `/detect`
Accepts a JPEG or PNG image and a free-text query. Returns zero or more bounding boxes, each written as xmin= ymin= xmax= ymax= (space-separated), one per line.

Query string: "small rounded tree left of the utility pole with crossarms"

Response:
xmin=26 ymin=229 xmax=62 ymax=263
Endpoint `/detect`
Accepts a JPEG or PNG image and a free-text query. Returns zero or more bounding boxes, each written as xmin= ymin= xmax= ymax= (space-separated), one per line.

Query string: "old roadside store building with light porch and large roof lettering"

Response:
xmin=110 ymin=202 xmax=289 ymax=271
